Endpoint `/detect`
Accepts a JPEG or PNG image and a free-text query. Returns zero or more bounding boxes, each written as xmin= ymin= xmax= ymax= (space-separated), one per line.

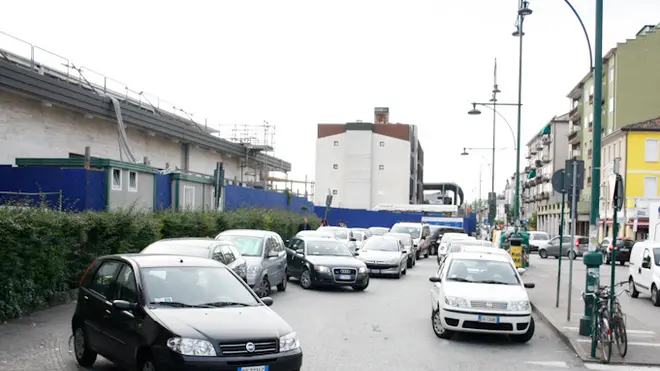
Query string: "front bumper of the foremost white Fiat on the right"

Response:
xmin=440 ymin=308 xmax=532 ymax=335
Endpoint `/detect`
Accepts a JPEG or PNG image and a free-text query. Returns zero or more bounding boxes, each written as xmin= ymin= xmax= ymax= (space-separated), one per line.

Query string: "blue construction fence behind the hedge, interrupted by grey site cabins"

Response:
xmin=0 ymin=165 xmax=314 ymax=213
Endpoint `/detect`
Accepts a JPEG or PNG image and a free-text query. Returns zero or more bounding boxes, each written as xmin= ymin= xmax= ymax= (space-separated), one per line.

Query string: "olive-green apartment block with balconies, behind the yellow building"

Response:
xmin=568 ymin=25 xmax=660 ymax=234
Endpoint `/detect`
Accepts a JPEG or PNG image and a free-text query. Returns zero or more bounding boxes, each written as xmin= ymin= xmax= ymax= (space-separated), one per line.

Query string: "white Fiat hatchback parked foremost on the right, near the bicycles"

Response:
xmin=429 ymin=252 xmax=534 ymax=343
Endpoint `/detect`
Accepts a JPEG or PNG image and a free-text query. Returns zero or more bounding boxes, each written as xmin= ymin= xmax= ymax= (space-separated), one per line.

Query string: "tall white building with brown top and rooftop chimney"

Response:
xmin=314 ymin=107 xmax=424 ymax=210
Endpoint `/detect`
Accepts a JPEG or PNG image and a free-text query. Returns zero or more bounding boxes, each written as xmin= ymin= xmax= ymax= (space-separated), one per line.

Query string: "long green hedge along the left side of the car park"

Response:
xmin=0 ymin=208 xmax=320 ymax=321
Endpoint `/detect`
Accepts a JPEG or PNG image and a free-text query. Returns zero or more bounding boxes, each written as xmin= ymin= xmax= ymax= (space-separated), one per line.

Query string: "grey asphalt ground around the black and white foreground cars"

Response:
xmin=0 ymin=258 xmax=657 ymax=371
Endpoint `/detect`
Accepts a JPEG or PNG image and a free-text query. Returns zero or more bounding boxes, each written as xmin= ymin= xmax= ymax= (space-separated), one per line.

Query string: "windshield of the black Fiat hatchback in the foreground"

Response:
xmin=141 ymin=267 xmax=259 ymax=308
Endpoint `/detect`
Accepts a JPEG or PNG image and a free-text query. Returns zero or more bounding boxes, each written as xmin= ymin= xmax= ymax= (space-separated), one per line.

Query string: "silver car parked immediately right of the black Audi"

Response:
xmin=357 ymin=236 xmax=408 ymax=278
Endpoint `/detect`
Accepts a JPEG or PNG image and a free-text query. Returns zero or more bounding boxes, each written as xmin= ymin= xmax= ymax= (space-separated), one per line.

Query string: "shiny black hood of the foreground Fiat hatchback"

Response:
xmin=151 ymin=306 xmax=293 ymax=342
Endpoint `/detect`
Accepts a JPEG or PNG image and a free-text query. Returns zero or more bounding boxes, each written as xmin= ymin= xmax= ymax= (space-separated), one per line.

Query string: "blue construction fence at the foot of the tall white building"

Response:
xmin=314 ymin=206 xmax=477 ymax=233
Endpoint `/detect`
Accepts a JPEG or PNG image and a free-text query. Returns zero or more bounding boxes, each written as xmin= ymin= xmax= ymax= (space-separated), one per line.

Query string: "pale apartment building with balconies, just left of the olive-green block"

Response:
xmin=522 ymin=113 xmax=569 ymax=235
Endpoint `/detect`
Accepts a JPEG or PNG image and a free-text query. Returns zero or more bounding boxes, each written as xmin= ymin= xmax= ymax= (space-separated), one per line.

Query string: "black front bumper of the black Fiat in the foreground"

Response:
xmin=157 ymin=349 xmax=303 ymax=371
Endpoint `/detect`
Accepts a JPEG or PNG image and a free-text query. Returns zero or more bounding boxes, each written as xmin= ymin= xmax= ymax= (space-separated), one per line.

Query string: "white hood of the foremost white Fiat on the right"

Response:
xmin=443 ymin=280 xmax=529 ymax=302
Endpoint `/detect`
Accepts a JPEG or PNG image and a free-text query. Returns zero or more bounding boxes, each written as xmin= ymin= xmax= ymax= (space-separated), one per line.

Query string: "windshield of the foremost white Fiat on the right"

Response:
xmin=447 ymin=259 xmax=520 ymax=285
